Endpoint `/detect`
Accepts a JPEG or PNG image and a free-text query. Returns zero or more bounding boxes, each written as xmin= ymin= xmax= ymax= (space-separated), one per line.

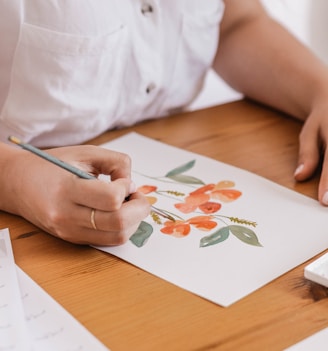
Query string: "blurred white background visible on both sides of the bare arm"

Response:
xmin=190 ymin=0 xmax=328 ymax=110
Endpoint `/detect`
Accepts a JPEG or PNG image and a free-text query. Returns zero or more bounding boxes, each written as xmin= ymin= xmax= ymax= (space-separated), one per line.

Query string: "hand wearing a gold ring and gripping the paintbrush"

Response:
xmin=0 ymin=146 xmax=149 ymax=245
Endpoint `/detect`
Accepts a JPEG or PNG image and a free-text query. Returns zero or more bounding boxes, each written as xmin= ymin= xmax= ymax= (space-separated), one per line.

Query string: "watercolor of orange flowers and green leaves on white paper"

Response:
xmin=130 ymin=160 xmax=262 ymax=248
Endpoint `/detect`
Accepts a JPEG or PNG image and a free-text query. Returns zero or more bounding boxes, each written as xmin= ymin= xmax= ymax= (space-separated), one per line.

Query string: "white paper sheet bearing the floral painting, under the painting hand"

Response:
xmin=98 ymin=133 xmax=328 ymax=306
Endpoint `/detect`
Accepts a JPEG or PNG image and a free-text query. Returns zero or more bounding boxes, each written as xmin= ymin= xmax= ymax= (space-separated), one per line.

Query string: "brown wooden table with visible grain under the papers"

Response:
xmin=0 ymin=101 xmax=328 ymax=351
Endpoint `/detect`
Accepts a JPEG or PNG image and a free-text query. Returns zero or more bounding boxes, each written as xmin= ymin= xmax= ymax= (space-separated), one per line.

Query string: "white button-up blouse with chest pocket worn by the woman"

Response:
xmin=0 ymin=0 xmax=224 ymax=146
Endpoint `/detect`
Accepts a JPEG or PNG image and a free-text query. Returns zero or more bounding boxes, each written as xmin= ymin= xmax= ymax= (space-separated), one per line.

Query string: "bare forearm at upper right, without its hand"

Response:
xmin=214 ymin=1 xmax=328 ymax=119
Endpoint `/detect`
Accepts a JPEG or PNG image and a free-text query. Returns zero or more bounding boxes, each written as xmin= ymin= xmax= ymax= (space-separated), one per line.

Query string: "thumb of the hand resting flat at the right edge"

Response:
xmin=294 ymin=123 xmax=320 ymax=181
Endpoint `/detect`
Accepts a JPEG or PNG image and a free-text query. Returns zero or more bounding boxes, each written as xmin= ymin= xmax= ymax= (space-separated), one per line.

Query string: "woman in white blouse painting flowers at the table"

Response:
xmin=0 ymin=0 xmax=328 ymax=245
